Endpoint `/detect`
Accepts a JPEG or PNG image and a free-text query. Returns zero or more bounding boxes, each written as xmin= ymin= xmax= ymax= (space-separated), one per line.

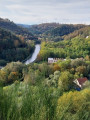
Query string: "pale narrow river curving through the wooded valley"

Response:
xmin=25 ymin=44 xmax=40 ymax=65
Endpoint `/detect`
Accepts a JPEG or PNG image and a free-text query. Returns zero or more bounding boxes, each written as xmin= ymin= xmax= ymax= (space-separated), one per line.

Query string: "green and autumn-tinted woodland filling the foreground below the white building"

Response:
xmin=0 ymin=59 xmax=90 ymax=120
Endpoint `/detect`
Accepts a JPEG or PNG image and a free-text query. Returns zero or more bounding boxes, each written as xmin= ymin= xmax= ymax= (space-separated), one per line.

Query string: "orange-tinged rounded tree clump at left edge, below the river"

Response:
xmin=0 ymin=62 xmax=25 ymax=85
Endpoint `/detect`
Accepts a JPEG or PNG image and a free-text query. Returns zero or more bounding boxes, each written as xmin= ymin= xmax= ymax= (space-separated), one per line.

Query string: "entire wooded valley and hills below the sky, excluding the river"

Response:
xmin=0 ymin=19 xmax=90 ymax=120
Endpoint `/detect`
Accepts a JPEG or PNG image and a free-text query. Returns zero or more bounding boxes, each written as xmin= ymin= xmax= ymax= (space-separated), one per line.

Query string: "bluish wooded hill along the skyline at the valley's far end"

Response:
xmin=28 ymin=23 xmax=86 ymax=37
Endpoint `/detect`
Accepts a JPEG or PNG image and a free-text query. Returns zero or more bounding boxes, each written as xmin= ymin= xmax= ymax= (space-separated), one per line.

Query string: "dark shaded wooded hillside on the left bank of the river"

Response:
xmin=0 ymin=28 xmax=34 ymax=66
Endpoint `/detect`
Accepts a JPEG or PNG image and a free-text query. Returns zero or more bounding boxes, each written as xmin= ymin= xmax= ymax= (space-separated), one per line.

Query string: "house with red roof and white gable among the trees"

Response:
xmin=73 ymin=77 xmax=88 ymax=90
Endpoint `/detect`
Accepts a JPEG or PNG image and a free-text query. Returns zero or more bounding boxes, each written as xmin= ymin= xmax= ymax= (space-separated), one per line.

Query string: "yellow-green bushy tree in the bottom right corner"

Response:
xmin=56 ymin=89 xmax=90 ymax=120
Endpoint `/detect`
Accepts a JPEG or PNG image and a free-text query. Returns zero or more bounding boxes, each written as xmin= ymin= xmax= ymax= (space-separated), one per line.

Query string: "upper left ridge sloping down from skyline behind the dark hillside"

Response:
xmin=0 ymin=18 xmax=37 ymax=40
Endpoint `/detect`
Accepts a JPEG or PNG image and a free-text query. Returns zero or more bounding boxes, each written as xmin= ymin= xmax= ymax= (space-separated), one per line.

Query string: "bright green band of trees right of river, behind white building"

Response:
xmin=37 ymin=37 xmax=90 ymax=61
